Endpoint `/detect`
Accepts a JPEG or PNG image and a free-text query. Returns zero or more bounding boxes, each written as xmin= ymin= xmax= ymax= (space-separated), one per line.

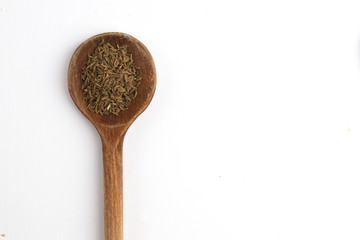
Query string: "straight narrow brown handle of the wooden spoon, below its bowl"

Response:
xmin=102 ymin=136 xmax=124 ymax=240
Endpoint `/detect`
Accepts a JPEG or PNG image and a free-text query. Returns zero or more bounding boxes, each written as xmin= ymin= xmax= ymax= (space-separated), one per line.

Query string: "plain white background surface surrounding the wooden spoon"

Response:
xmin=0 ymin=0 xmax=360 ymax=240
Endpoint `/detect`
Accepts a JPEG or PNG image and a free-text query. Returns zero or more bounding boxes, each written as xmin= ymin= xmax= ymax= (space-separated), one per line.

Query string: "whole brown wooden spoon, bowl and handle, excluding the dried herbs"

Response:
xmin=68 ymin=32 xmax=156 ymax=240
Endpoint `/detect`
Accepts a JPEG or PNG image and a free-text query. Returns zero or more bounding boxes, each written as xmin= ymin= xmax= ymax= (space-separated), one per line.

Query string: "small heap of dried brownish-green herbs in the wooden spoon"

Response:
xmin=81 ymin=40 xmax=141 ymax=115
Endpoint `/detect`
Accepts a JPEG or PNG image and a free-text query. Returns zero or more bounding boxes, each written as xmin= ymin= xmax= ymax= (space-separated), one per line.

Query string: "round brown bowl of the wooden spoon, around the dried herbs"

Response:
xmin=68 ymin=32 xmax=156 ymax=128
